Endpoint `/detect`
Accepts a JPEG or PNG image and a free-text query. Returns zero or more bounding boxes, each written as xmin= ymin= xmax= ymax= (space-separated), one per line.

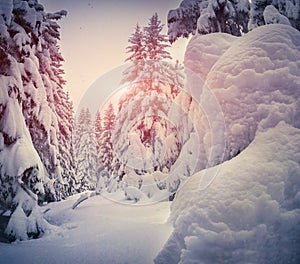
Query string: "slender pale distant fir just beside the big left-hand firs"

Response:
xmin=74 ymin=108 xmax=99 ymax=192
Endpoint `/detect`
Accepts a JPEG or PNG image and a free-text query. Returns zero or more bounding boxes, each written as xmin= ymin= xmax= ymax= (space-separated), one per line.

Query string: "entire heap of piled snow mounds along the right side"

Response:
xmin=155 ymin=25 xmax=300 ymax=263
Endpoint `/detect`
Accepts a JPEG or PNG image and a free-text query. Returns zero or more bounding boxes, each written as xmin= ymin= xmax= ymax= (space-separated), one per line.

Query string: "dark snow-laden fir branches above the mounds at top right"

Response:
xmin=168 ymin=0 xmax=300 ymax=43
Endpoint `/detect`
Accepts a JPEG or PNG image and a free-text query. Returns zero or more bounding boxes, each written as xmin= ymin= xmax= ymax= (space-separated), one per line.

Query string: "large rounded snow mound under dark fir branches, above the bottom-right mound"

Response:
xmin=204 ymin=24 xmax=300 ymax=160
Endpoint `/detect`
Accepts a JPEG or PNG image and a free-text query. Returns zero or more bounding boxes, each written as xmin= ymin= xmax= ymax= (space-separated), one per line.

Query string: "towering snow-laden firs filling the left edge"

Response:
xmin=0 ymin=0 xmax=74 ymax=240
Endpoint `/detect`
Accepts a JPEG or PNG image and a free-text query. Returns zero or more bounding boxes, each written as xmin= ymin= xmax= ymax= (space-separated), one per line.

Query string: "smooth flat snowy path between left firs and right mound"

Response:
xmin=0 ymin=196 xmax=172 ymax=264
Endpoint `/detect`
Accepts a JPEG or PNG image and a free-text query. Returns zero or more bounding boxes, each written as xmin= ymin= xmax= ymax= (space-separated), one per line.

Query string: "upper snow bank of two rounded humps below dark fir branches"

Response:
xmin=185 ymin=24 xmax=300 ymax=160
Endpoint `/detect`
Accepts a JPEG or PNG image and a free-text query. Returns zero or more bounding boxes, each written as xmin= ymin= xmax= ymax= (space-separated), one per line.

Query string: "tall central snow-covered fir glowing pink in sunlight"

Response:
xmin=112 ymin=13 xmax=183 ymax=194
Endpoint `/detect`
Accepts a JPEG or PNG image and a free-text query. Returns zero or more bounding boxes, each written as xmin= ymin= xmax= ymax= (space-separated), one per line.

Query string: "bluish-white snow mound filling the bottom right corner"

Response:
xmin=155 ymin=122 xmax=300 ymax=263
